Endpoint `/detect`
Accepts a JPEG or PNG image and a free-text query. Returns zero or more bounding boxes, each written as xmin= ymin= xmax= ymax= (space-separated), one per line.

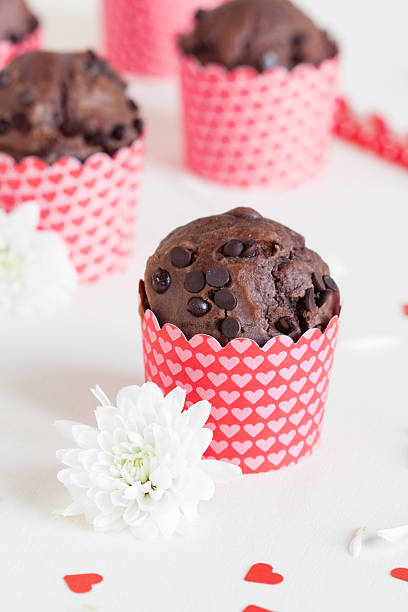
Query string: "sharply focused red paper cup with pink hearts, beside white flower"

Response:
xmin=142 ymin=310 xmax=338 ymax=474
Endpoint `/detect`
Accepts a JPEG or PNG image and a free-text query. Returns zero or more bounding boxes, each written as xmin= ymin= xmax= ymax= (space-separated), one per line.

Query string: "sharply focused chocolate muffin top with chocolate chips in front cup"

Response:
xmin=142 ymin=208 xmax=340 ymax=346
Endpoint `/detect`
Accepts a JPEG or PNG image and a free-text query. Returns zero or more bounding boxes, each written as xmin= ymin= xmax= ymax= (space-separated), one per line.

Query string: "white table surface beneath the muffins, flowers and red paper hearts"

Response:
xmin=0 ymin=0 xmax=408 ymax=612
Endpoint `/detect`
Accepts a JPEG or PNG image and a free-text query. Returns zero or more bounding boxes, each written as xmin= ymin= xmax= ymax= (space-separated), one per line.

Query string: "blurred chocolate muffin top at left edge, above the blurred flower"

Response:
xmin=0 ymin=51 xmax=143 ymax=163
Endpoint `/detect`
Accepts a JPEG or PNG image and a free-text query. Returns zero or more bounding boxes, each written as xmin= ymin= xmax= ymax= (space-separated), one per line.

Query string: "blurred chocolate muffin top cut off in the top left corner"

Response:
xmin=0 ymin=0 xmax=38 ymax=44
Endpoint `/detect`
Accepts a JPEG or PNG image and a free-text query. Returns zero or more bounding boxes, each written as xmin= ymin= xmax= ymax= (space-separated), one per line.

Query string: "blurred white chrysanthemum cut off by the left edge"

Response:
xmin=0 ymin=202 xmax=76 ymax=321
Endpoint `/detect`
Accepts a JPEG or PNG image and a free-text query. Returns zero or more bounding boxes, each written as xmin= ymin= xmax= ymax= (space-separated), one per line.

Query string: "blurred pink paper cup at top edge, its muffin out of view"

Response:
xmin=103 ymin=0 xmax=222 ymax=77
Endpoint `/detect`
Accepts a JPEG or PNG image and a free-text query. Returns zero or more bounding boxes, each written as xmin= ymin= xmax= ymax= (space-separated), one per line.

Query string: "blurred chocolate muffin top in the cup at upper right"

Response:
xmin=179 ymin=0 xmax=338 ymax=72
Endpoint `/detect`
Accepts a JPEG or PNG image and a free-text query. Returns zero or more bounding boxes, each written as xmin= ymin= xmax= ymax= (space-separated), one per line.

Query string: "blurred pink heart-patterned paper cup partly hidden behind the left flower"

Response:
xmin=0 ymin=137 xmax=144 ymax=283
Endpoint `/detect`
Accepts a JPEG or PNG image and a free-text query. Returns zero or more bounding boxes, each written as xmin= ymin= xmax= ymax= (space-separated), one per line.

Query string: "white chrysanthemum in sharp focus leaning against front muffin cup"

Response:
xmin=57 ymin=382 xmax=242 ymax=538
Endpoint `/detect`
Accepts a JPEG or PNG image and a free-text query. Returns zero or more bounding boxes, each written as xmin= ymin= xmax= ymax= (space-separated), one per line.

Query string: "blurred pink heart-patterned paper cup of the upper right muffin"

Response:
xmin=180 ymin=53 xmax=340 ymax=189
